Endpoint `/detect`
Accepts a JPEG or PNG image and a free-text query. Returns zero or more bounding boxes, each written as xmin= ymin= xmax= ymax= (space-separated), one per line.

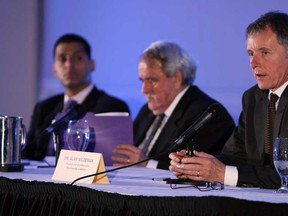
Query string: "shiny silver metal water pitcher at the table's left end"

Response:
xmin=0 ymin=116 xmax=26 ymax=172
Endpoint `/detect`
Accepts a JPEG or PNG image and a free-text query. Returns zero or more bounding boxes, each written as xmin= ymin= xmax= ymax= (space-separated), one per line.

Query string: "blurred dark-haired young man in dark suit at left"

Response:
xmin=23 ymin=34 xmax=129 ymax=160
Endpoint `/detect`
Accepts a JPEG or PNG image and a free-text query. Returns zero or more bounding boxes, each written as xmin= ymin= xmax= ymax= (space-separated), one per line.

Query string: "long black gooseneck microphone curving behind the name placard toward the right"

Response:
xmin=71 ymin=103 xmax=220 ymax=185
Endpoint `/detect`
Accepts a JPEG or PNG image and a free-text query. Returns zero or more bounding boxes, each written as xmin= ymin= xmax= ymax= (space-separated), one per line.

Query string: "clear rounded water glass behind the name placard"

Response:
xmin=66 ymin=119 xmax=90 ymax=151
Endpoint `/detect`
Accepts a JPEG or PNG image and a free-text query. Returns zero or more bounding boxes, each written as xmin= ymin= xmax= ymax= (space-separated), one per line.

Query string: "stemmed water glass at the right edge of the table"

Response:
xmin=273 ymin=137 xmax=288 ymax=193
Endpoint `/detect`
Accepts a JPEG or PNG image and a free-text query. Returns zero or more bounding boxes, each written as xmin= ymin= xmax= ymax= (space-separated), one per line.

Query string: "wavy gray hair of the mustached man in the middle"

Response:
xmin=141 ymin=41 xmax=196 ymax=85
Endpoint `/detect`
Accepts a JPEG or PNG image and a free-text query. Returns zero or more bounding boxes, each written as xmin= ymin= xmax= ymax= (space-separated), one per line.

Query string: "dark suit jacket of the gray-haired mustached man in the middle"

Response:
xmin=134 ymin=86 xmax=234 ymax=169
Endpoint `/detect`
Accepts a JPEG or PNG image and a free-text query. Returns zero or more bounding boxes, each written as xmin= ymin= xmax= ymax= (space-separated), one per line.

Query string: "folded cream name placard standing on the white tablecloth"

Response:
xmin=52 ymin=149 xmax=110 ymax=184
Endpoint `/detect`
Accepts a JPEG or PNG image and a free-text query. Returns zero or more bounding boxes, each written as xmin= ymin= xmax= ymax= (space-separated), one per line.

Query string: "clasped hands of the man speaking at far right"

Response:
xmin=169 ymin=150 xmax=225 ymax=184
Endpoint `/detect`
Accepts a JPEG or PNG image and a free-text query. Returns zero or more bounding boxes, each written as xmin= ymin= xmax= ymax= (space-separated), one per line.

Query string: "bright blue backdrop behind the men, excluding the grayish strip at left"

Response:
xmin=38 ymin=0 xmax=288 ymax=121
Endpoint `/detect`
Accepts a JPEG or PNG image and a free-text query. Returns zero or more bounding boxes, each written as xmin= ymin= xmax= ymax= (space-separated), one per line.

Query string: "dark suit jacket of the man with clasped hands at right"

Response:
xmin=218 ymin=85 xmax=288 ymax=188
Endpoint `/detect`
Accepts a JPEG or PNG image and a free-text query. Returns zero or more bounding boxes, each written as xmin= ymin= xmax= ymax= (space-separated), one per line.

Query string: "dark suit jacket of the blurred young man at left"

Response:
xmin=23 ymin=87 xmax=129 ymax=160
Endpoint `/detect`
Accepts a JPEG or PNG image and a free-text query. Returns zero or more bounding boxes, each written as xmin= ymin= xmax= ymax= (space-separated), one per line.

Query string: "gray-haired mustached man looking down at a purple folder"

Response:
xmin=112 ymin=41 xmax=234 ymax=169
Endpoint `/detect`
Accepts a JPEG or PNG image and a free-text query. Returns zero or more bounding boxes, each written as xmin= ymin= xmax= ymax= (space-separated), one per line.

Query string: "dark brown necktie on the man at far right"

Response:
xmin=264 ymin=93 xmax=279 ymax=164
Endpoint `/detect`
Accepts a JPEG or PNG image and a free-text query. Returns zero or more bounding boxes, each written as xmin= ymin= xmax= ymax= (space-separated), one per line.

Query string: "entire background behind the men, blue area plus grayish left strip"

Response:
xmin=0 ymin=0 xmax=288 ymax=126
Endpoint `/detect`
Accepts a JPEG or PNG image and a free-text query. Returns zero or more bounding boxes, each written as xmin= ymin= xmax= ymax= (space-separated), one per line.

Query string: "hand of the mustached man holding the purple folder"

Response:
xmin=112 ymin=144 xmax=148 ymax=167
